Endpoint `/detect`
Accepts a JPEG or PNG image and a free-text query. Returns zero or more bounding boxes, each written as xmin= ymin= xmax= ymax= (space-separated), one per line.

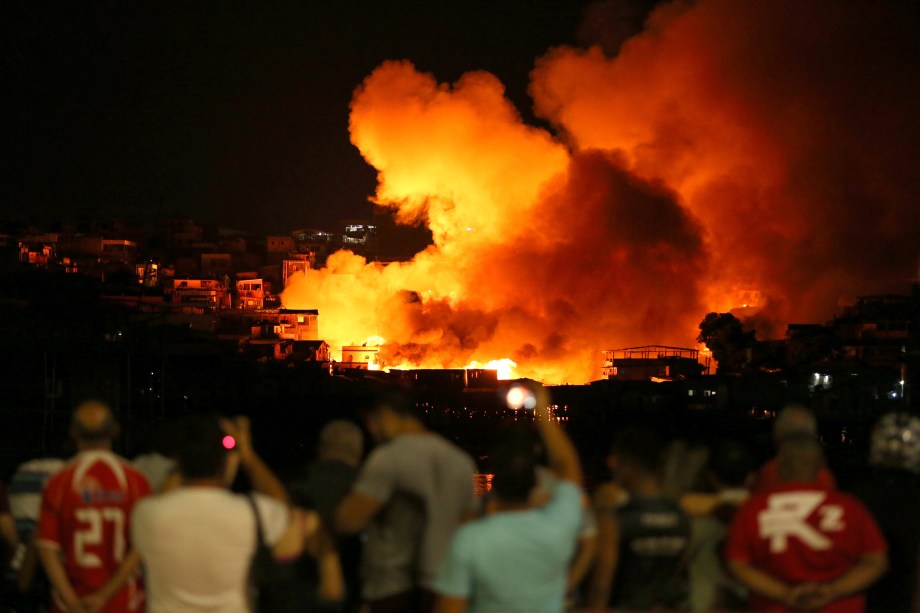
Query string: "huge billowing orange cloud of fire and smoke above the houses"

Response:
xmin=283 ymin=0 xmax=920 ymax=383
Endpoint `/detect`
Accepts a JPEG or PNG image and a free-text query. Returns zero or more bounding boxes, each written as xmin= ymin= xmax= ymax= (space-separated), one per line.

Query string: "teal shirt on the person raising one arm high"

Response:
xmin=435 ymin=481 xmax=582 ymax=613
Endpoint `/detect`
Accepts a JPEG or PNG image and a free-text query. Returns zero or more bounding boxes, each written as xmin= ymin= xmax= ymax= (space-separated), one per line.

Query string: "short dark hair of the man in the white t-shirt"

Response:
xmin=174 ymin=415 xmax=227 ymax=479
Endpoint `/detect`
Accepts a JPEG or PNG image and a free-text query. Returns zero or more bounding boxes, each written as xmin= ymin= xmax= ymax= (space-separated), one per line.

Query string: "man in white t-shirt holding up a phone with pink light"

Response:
xmin=132 ymin=416 xmax=344 ymax=613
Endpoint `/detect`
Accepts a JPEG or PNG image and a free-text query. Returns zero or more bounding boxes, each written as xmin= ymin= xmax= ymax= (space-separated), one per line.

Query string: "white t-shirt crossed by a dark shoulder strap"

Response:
xmin=131 ymin=487 xmax=289 ymax=613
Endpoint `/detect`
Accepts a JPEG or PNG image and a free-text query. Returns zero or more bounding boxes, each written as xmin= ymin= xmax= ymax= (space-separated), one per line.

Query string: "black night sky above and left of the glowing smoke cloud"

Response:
xmin=0 ymin=0 xmax=653 ymax=232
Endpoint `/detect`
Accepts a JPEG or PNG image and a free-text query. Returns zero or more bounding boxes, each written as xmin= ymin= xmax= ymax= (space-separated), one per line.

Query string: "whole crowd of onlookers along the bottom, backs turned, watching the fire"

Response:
xmin=0 ymin=384 xmax=920 ymax=613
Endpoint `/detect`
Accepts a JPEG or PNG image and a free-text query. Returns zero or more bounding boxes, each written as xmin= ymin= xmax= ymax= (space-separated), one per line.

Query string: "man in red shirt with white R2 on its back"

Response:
xmin=725 ymin=437 xmax=888 ymax=613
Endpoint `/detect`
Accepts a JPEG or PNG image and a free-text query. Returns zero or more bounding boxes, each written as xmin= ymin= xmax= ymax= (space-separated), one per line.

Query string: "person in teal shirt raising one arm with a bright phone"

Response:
xmin=436 ymin=386 xmax=583 ymax=613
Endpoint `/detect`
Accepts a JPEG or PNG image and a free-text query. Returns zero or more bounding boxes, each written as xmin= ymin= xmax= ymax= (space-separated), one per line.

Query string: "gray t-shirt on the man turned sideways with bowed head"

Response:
xmin=354 ymin=432 xmax=476 ymax=600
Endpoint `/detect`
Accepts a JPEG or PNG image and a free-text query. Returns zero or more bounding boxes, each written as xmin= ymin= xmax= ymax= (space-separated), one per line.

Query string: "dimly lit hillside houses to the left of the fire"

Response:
xmin=6 ymin=219 xmax=376 ymax=368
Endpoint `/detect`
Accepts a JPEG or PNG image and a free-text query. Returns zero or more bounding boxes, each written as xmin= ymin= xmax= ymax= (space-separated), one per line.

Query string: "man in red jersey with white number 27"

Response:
xmin=38 ymin=401 xmax=150 ymax=613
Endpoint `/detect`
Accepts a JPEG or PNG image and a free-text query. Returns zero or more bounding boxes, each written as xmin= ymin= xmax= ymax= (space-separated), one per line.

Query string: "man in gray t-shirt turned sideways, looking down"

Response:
xmin=336 ymin=390 xmax=476 ymax=613
